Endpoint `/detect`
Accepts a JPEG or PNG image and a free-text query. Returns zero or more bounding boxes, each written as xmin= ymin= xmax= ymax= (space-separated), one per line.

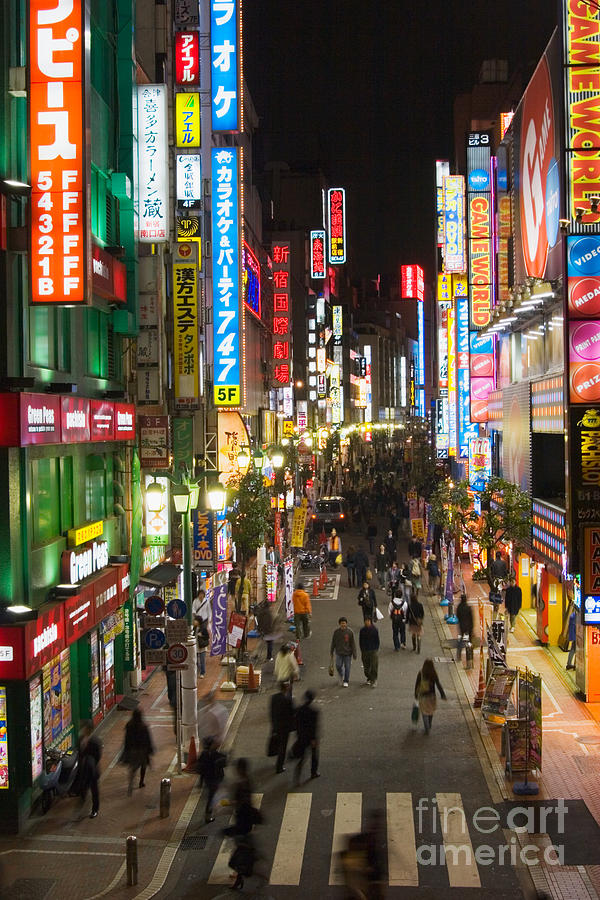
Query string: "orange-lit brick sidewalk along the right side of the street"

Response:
xmin=436 ymin=566 xmax=600 ymax=900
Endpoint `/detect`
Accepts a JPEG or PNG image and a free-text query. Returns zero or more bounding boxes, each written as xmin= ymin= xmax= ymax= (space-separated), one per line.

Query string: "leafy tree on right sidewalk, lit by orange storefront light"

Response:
xmin=431 ymin=477 xmax=532 ymax=590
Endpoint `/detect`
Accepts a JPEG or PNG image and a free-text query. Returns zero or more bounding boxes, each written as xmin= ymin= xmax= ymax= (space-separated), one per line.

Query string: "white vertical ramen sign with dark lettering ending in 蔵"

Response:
xmin=137 ymin=84 xmax=169 ymax=244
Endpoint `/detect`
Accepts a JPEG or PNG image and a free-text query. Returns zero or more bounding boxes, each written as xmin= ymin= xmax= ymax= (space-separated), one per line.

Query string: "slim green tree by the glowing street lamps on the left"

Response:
xmin=227 ymin=466 xmax=271 ymax=612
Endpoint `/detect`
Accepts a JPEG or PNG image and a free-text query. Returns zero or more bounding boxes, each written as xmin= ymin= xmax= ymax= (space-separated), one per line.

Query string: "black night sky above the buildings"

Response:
xmin=244 ymin=0 xmax=557 ymax=279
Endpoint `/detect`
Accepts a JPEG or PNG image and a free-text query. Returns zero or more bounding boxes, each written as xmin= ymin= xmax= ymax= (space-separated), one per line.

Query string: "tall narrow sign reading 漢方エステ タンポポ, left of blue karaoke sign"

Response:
xmin=173 ymin=242 xmax=200 ymax=409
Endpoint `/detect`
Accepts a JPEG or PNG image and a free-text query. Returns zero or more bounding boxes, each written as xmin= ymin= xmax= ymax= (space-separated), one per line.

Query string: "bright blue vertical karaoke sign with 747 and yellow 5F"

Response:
xmin=211 ymin=146 xmax=241 ymax=406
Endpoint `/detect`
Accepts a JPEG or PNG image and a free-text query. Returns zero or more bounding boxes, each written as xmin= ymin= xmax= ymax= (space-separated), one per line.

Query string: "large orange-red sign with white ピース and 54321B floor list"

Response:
xmin=28 ymin=0 xmax=91 ymax=305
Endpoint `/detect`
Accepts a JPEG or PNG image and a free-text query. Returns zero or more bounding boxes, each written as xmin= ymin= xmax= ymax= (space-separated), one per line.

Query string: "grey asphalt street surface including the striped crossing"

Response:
xmin=160 ymin=535 xmax=524 ymax=900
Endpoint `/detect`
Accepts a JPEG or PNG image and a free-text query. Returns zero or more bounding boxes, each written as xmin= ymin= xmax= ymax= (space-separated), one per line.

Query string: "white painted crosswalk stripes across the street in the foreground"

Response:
xmin=208 ymin=791 xmax=488 ymax=889
